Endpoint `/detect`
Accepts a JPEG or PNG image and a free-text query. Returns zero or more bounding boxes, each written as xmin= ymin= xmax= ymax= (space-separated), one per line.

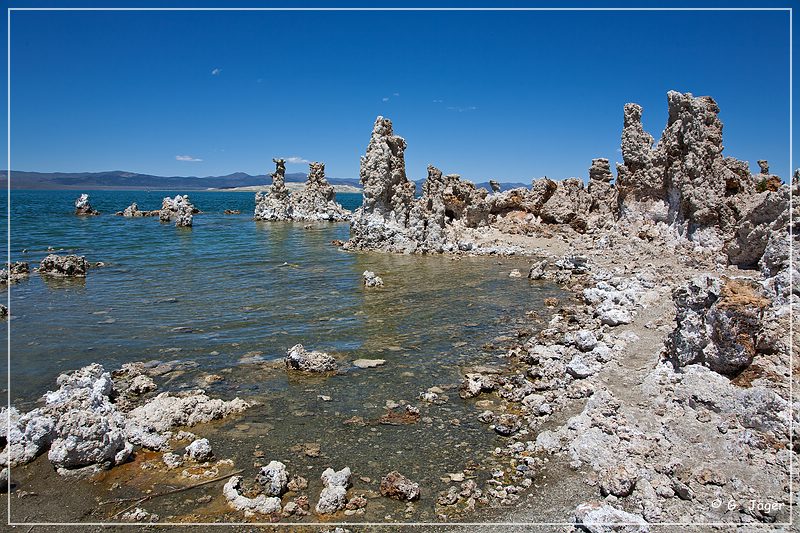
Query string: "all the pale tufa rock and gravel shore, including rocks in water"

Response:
xmin=4 ymin=92 xmax=800 ymax=531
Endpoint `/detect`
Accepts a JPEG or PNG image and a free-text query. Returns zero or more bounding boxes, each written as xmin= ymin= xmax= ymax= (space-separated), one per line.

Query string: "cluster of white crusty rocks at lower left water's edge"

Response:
xmin=0 ymin=364 xmax=249 ymax=473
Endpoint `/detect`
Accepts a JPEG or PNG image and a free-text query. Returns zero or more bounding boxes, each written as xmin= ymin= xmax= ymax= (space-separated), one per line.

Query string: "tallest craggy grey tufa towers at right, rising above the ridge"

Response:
xmin=617 ymin=91 xmax=781 ymax=251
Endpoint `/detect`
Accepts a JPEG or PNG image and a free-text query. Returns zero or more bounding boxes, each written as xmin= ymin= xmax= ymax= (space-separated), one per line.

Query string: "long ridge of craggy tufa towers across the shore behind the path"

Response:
xmin=345 ymin=91 xmax=800 ymax=274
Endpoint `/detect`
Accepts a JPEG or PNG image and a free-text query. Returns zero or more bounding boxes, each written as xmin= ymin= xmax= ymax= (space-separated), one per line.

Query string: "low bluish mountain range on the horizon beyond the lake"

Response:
xmin=0 ymin=170 xmax=528 ymax=193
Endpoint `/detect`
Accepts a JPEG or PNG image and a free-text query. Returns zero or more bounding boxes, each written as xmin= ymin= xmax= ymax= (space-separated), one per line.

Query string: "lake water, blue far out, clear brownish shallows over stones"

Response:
xmin=1 ymin=191 xmax=563 ymax=521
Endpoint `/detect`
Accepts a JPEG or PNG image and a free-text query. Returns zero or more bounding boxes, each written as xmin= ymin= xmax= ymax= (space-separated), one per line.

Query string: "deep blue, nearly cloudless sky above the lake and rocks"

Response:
xmin=3 ymin=4 xmax=796 ymax=182
